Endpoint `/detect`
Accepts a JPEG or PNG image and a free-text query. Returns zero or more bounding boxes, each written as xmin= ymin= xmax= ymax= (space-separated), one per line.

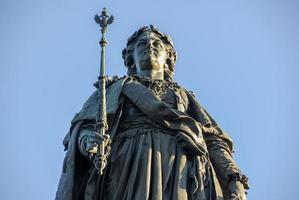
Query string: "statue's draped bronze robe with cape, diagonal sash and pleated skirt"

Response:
xmin=56 ymin=77 xmax=239 ymax=200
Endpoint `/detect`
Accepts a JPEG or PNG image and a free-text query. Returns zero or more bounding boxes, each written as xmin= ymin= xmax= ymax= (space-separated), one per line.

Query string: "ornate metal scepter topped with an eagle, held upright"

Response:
xmin=94 ymin=8 xmax=114 ymax=175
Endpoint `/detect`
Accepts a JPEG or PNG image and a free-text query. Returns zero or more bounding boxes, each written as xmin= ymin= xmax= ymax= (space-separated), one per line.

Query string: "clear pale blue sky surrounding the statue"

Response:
xmin=0 ymin=0 xmax=299 ymax=200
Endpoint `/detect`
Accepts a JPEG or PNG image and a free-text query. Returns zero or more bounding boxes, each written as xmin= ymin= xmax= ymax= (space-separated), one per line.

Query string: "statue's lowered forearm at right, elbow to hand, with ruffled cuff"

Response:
xmin=202 ymin=111 xmax=249 ymax=200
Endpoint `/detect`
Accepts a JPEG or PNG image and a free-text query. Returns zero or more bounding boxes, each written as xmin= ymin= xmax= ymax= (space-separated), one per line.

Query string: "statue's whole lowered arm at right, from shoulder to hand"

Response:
xmin=187 ymin=92 xmax=249 ymax=199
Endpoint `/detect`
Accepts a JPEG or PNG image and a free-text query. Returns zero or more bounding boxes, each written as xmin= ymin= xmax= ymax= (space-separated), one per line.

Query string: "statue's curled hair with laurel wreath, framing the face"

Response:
xmin=122 ymin=25 xmax=177 ymax=80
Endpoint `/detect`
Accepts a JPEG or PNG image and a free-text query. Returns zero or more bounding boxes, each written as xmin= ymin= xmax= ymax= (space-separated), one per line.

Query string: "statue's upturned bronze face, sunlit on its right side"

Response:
xmin=133 ymin=31 xmax=167 ymax=74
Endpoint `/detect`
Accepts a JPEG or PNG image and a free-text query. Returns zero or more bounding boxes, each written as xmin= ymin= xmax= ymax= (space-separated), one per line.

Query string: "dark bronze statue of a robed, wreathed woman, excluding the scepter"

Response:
xmin=56 ymin=23 xmax=248 ymax=200
